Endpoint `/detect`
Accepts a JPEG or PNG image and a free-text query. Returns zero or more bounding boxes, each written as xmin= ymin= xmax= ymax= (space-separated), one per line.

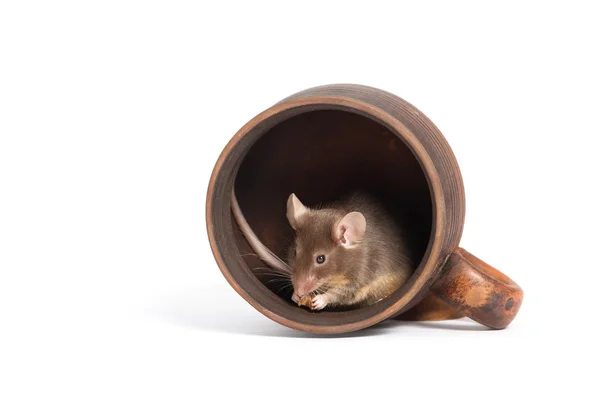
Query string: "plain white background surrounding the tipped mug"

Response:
xmin=0 ymin=0 xmax=600 ymax=399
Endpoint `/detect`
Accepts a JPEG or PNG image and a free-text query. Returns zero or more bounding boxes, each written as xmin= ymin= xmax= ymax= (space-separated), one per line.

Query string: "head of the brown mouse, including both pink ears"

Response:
xmin=287 ymin=194 xmax=367 ymax=297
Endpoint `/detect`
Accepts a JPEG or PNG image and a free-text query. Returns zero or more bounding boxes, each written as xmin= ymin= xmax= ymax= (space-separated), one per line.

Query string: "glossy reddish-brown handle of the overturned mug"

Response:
xmin=431 ymin=247 xmax=523 ymax=329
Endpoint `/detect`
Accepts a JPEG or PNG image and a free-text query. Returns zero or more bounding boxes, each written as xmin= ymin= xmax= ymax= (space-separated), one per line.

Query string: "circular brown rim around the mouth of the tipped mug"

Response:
xmin=205 ymin=95 xmax=448 ymax=334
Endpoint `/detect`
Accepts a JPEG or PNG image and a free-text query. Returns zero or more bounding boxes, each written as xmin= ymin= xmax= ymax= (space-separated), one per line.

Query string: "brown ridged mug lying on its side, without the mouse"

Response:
xmin=206 ymin=84 xmax=523 ymax=334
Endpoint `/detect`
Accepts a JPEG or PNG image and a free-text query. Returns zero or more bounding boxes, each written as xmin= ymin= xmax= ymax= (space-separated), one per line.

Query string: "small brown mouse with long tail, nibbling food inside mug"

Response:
xmin=227 ymin=191 xmax=415 ymax=311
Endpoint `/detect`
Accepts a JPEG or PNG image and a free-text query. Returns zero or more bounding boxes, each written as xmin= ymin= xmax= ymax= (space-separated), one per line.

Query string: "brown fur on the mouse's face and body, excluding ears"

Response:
xmin=288 ymin=193 xmax=414 ymax=305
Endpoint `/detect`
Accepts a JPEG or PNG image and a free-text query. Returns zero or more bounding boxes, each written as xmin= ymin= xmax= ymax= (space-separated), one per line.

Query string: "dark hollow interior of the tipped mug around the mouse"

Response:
xmin=212 ymin=104 xmax=435 ymax=327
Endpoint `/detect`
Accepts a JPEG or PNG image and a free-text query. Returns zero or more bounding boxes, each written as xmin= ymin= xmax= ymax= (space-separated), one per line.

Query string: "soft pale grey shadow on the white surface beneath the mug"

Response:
xmin=148 ymin=286 xmax=489 ymax=339
